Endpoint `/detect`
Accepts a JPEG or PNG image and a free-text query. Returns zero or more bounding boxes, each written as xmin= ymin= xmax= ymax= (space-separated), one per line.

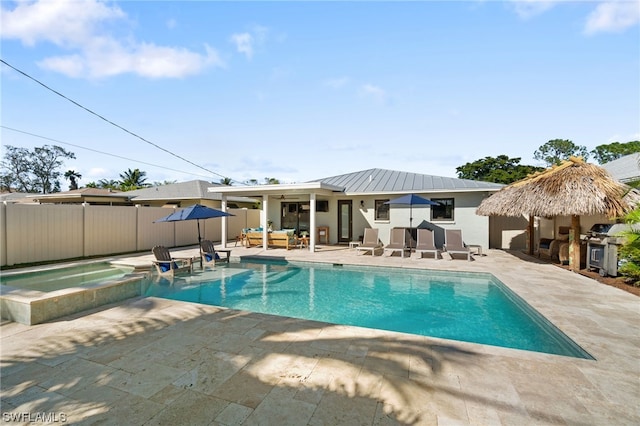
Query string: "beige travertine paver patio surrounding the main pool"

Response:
xmin=0 ymin=247 xmax=640 ymax=425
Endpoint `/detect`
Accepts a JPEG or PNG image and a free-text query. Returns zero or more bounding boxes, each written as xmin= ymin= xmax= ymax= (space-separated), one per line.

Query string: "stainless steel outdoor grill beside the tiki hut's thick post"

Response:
xmin=586 ymin=223 xmax=626 ymax=277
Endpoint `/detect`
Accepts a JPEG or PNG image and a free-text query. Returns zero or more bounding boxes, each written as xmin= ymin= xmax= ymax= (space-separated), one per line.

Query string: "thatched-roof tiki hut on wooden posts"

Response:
xmin=476 ymin=157 xmax=640 ymax=271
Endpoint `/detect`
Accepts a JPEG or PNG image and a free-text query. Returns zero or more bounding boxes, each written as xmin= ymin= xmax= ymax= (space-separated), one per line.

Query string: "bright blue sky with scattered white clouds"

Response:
xmin=0 ymin=0 xmax=640 ymax=190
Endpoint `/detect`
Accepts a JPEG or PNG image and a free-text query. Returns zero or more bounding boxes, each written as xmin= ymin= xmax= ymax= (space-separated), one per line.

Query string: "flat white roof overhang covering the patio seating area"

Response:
xmin=207 ymin=182 xmax=344 ymax=197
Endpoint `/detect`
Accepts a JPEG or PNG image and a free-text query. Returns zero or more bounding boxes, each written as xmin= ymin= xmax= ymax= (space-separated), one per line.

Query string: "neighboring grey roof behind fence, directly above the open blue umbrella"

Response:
xmin=127 ymin=180 xmax=253 ymax=203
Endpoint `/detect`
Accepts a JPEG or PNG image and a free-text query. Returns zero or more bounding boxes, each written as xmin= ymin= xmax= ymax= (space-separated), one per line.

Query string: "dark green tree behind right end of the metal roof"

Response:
xmin=456 ymin=155 xmax=543 ymax=184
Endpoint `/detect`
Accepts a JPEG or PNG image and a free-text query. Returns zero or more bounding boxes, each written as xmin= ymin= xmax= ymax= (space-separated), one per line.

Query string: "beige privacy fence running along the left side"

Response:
xmin=0 ymin=204 xmax=260 ymax=266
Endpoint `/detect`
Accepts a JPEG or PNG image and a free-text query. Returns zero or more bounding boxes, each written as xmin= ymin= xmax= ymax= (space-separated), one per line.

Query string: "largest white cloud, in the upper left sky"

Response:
xmin=0 ymin=0 xmax=224 ymax=78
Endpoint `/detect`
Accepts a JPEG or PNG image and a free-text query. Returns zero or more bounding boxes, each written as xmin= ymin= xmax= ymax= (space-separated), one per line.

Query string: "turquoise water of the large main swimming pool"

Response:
xmin=146 ymin=262 xmax=592 ymax=359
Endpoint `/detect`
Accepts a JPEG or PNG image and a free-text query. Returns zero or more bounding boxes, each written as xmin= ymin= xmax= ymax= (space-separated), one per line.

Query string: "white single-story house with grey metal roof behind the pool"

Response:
xmin=208 ymin=169 xmax=503 ymax=250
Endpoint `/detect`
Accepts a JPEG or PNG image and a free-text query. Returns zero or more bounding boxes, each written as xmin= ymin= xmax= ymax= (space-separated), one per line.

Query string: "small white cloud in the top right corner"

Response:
xmin=584 ymin=0 xmax=640 ymax=34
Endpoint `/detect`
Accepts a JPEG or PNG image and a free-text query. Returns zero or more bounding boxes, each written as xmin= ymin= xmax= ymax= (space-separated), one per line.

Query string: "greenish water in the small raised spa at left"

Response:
xmin=0 ymin=262 xmax=134 ymax=292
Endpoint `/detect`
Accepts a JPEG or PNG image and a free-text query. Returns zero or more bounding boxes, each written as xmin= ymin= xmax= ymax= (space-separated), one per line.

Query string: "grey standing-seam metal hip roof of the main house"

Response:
xmin=312 ymin=169 xmax=504 ymax=194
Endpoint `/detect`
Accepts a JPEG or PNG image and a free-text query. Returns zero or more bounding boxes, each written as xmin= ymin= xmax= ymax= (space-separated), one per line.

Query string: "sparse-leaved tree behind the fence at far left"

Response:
xmin=2 ymin=145 xmax=76 ymax=194
